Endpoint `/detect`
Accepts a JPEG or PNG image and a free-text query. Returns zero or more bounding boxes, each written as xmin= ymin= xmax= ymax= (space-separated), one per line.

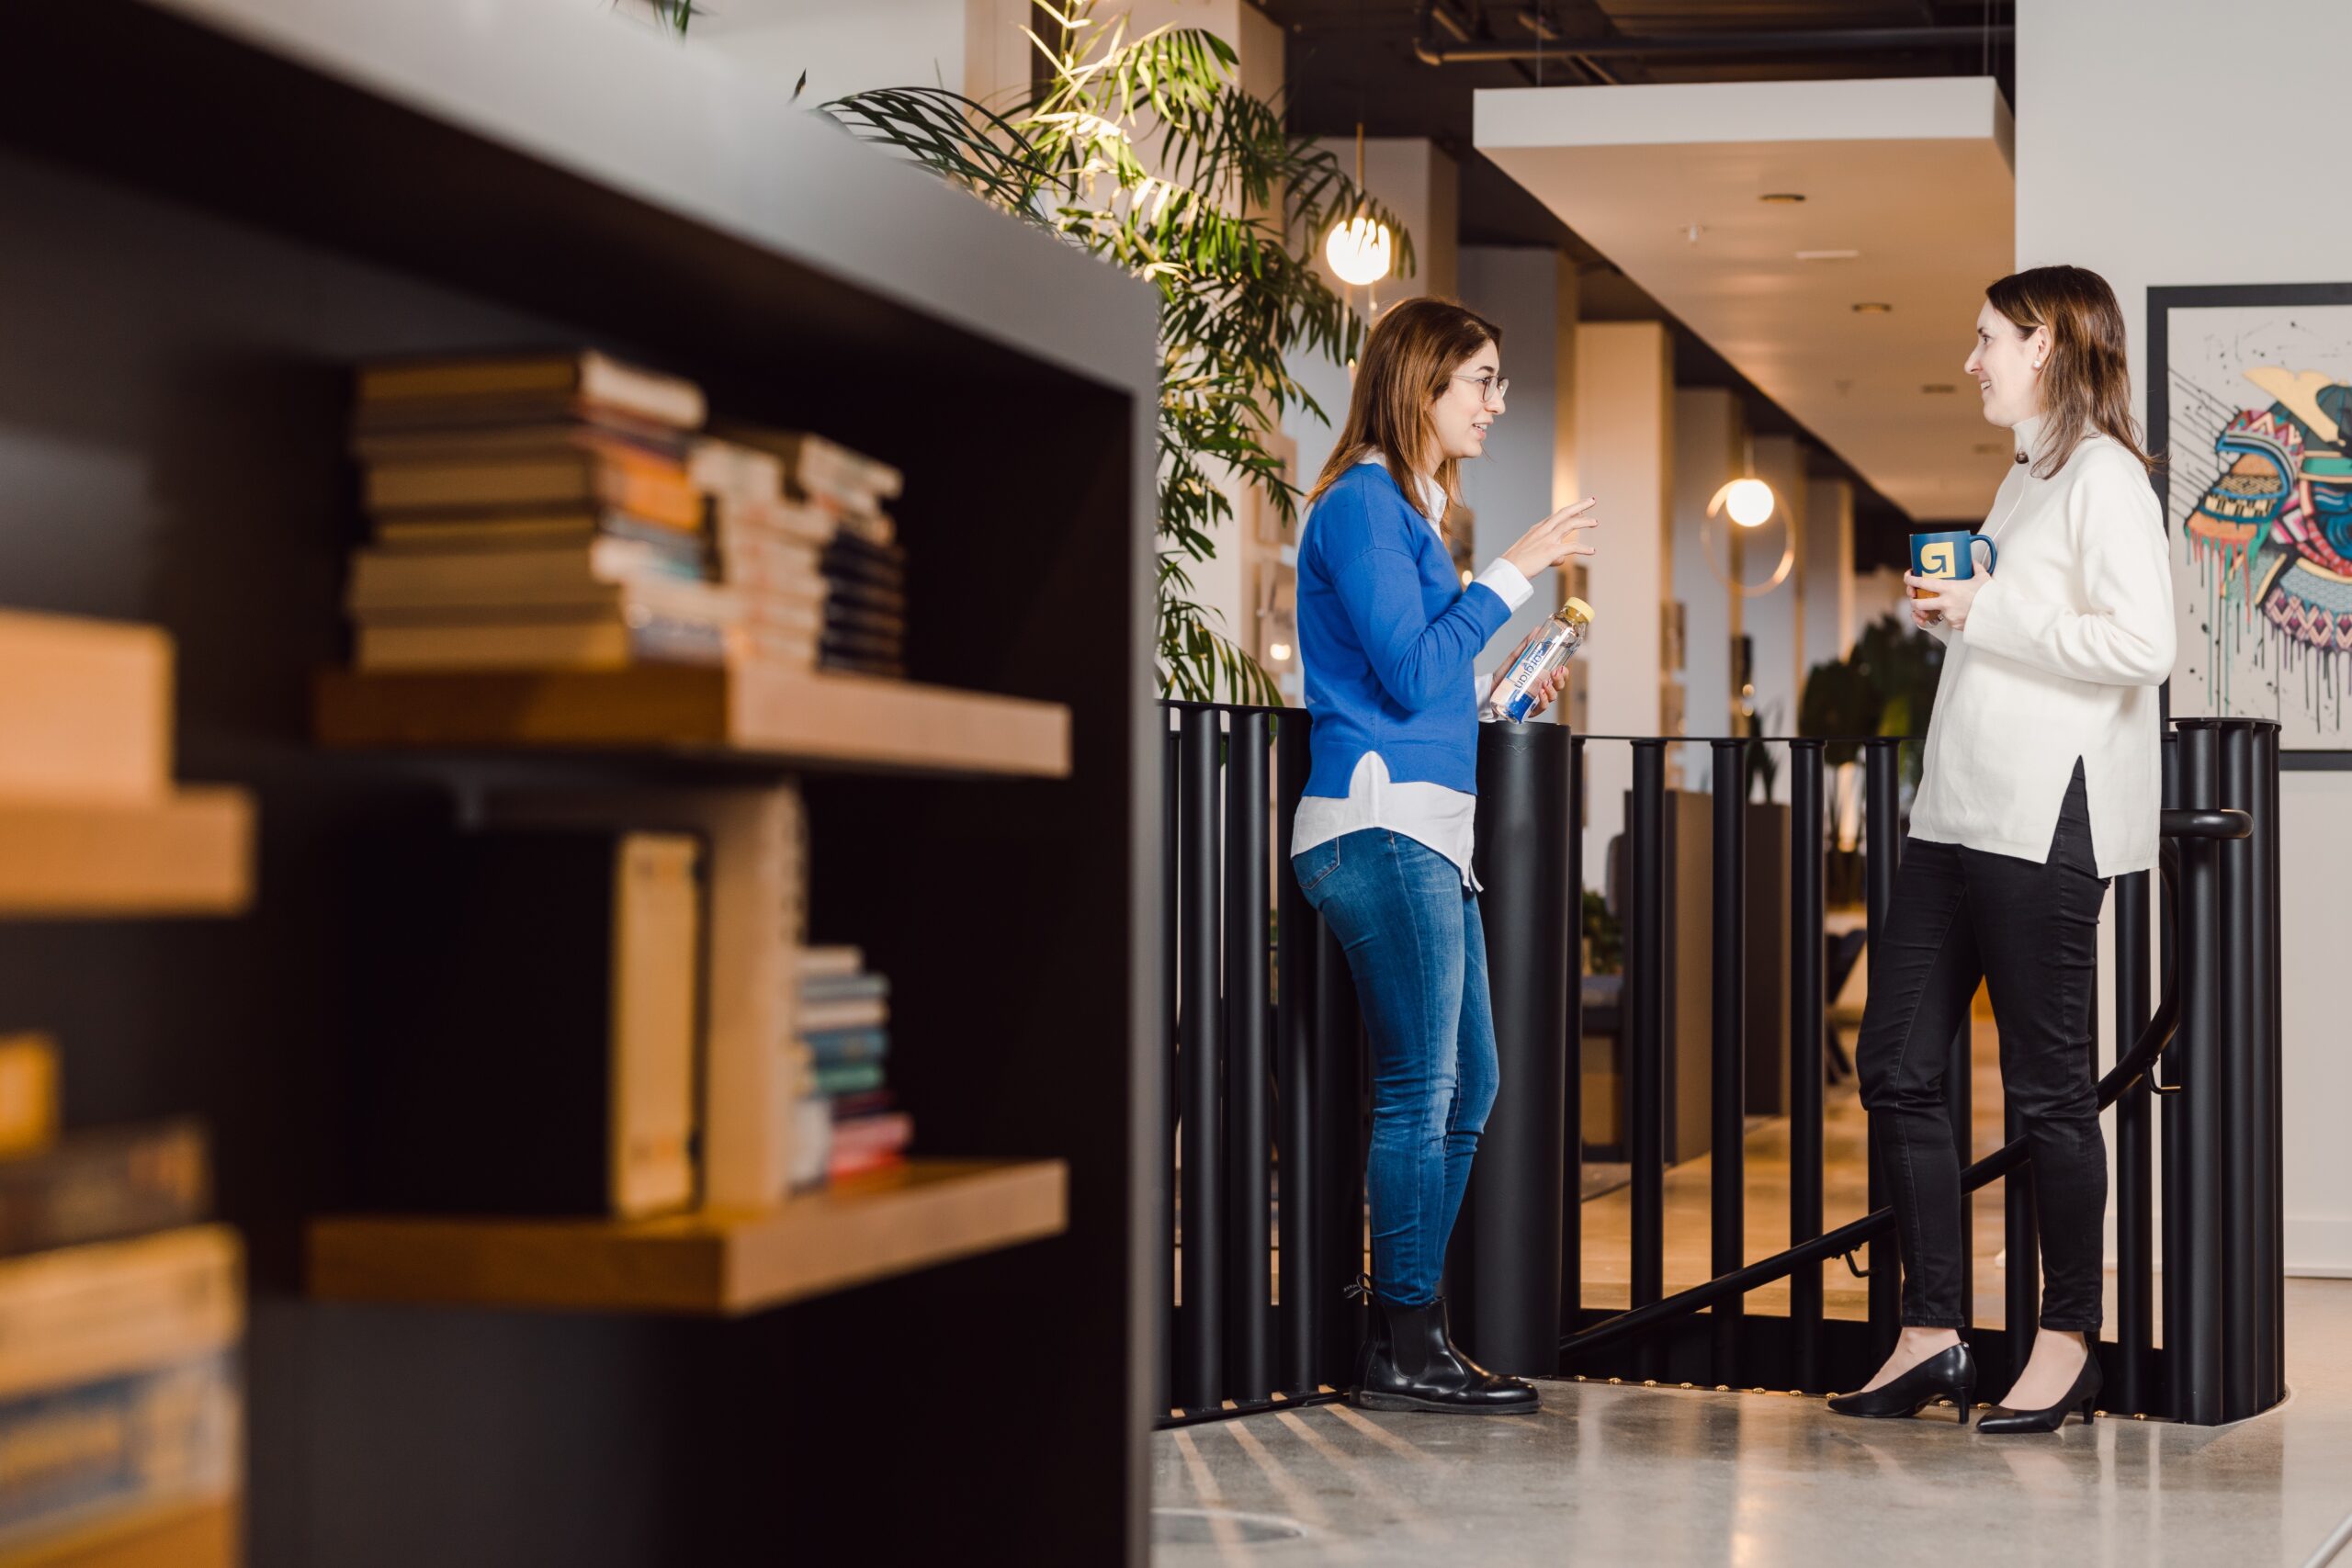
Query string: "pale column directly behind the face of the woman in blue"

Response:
xmin=1458 ymin=247 xmax=1576 ymax=682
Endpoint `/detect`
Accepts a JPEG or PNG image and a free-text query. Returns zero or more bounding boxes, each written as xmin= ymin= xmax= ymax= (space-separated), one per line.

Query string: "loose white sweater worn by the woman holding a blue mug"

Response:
xmin=1910 ymin=419 xmax=2173 ymax=877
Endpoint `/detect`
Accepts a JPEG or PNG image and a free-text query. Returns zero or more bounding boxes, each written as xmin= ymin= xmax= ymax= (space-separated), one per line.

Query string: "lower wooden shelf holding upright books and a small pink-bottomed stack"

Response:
xmin=311 ymin=1159 xmax=1068 ymax=1316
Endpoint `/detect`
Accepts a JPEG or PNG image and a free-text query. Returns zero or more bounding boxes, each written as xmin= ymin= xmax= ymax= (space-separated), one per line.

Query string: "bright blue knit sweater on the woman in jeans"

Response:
xmin=1298 ymin=453 xmax=1510 ymax=797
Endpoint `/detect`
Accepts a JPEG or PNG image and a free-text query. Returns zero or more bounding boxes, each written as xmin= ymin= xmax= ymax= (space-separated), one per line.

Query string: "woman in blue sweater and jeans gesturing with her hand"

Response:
xmin=1291 ymin=299 xmax=1592 ymax=1411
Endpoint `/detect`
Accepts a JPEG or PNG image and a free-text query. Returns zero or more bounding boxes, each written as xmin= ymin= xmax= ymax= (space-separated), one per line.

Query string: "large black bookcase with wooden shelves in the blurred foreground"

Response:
xmin=0 ymin=0 xmax=1162 ymax=1568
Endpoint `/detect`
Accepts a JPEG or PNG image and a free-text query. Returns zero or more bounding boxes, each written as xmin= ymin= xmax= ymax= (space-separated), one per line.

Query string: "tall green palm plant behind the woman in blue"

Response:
xmin=663 ymin=0 xmax=1414 ymax=703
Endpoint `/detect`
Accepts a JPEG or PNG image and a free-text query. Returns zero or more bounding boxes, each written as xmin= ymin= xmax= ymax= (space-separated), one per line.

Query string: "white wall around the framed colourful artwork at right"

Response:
xmin=2018 ymin=0 xmax=2352 ymax=1274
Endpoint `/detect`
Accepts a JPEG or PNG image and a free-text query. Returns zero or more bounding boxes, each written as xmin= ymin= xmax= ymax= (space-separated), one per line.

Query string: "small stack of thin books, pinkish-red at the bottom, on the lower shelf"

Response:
xmin=799 ymin=947 xmax=915 ymax=1180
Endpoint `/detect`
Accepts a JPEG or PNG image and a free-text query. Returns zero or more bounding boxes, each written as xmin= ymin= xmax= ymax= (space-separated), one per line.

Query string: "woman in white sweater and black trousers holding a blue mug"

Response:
xmin=1830 ymin=265 xmax=2173 ymax=1432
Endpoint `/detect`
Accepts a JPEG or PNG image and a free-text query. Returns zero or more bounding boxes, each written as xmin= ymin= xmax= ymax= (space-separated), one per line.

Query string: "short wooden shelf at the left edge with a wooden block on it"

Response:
xmin=0 ymin=787 xmax=254 ymax=917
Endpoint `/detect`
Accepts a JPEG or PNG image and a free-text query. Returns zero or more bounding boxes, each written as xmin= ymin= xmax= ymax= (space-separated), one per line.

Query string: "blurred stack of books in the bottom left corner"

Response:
xmin=0 ymin=1037 xmax=244 ymax=1561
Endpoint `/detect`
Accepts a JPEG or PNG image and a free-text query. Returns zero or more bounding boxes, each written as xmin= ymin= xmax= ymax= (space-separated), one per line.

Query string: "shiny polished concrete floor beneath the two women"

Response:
xmin=1152 ymin=1279 xmax=2352 ymax=1568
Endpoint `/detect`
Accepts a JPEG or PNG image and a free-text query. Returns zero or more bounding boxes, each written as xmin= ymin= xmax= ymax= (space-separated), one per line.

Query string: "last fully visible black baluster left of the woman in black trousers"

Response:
xmin=1788 ymin=740 xmax=1826 ymax=1394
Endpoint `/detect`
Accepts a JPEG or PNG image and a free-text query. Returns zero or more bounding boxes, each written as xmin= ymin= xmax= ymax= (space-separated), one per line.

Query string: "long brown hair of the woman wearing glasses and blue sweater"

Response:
xmin=1307 ymin=296 xmax=1503 ymax=522
